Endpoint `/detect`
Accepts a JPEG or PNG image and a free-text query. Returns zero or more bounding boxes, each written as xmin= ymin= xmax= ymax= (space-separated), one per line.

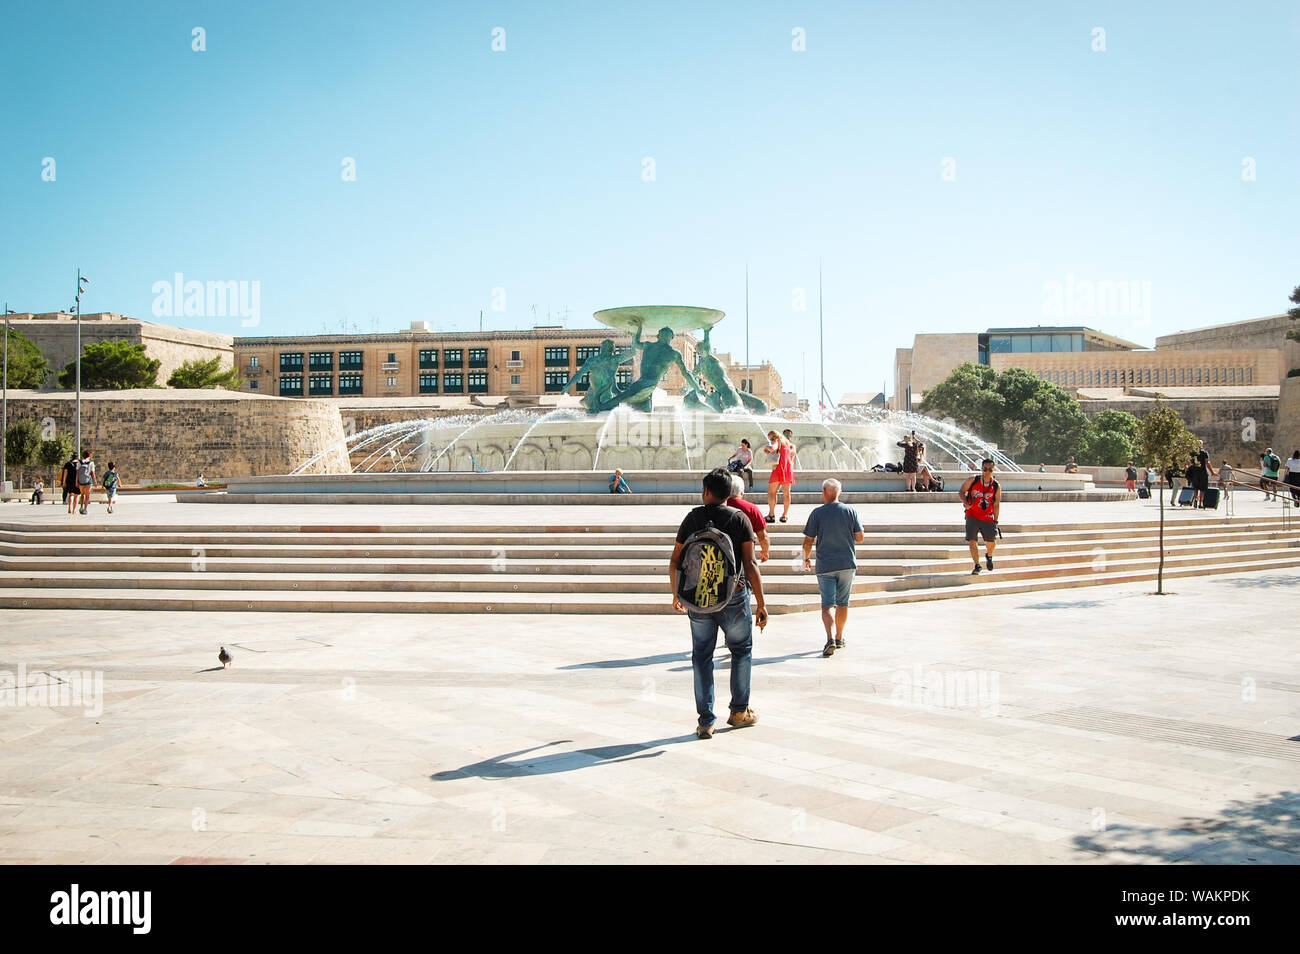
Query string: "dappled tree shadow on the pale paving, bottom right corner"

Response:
xmin=1074 ymin=792 xmax=1300 ymax=864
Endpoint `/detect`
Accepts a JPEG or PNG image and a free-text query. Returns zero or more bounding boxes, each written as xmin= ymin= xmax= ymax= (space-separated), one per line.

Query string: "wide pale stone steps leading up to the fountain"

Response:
xmin=0 ymin=515 xmax=1300 ymax=613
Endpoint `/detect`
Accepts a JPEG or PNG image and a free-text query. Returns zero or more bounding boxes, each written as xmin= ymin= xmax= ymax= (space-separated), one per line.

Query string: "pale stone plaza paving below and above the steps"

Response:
xmin=0 ymin=499 xmax=1300 ymax=863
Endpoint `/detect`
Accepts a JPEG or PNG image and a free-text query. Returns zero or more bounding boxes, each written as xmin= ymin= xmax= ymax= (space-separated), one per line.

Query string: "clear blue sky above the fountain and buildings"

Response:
xmin=0 ymin=0 xmax=1300 ymax=398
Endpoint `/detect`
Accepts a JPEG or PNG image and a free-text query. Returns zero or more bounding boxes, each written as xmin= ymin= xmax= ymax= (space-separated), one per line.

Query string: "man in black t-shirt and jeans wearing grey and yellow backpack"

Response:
xmin=668 ymin=467 xmax=767 ymax=738
